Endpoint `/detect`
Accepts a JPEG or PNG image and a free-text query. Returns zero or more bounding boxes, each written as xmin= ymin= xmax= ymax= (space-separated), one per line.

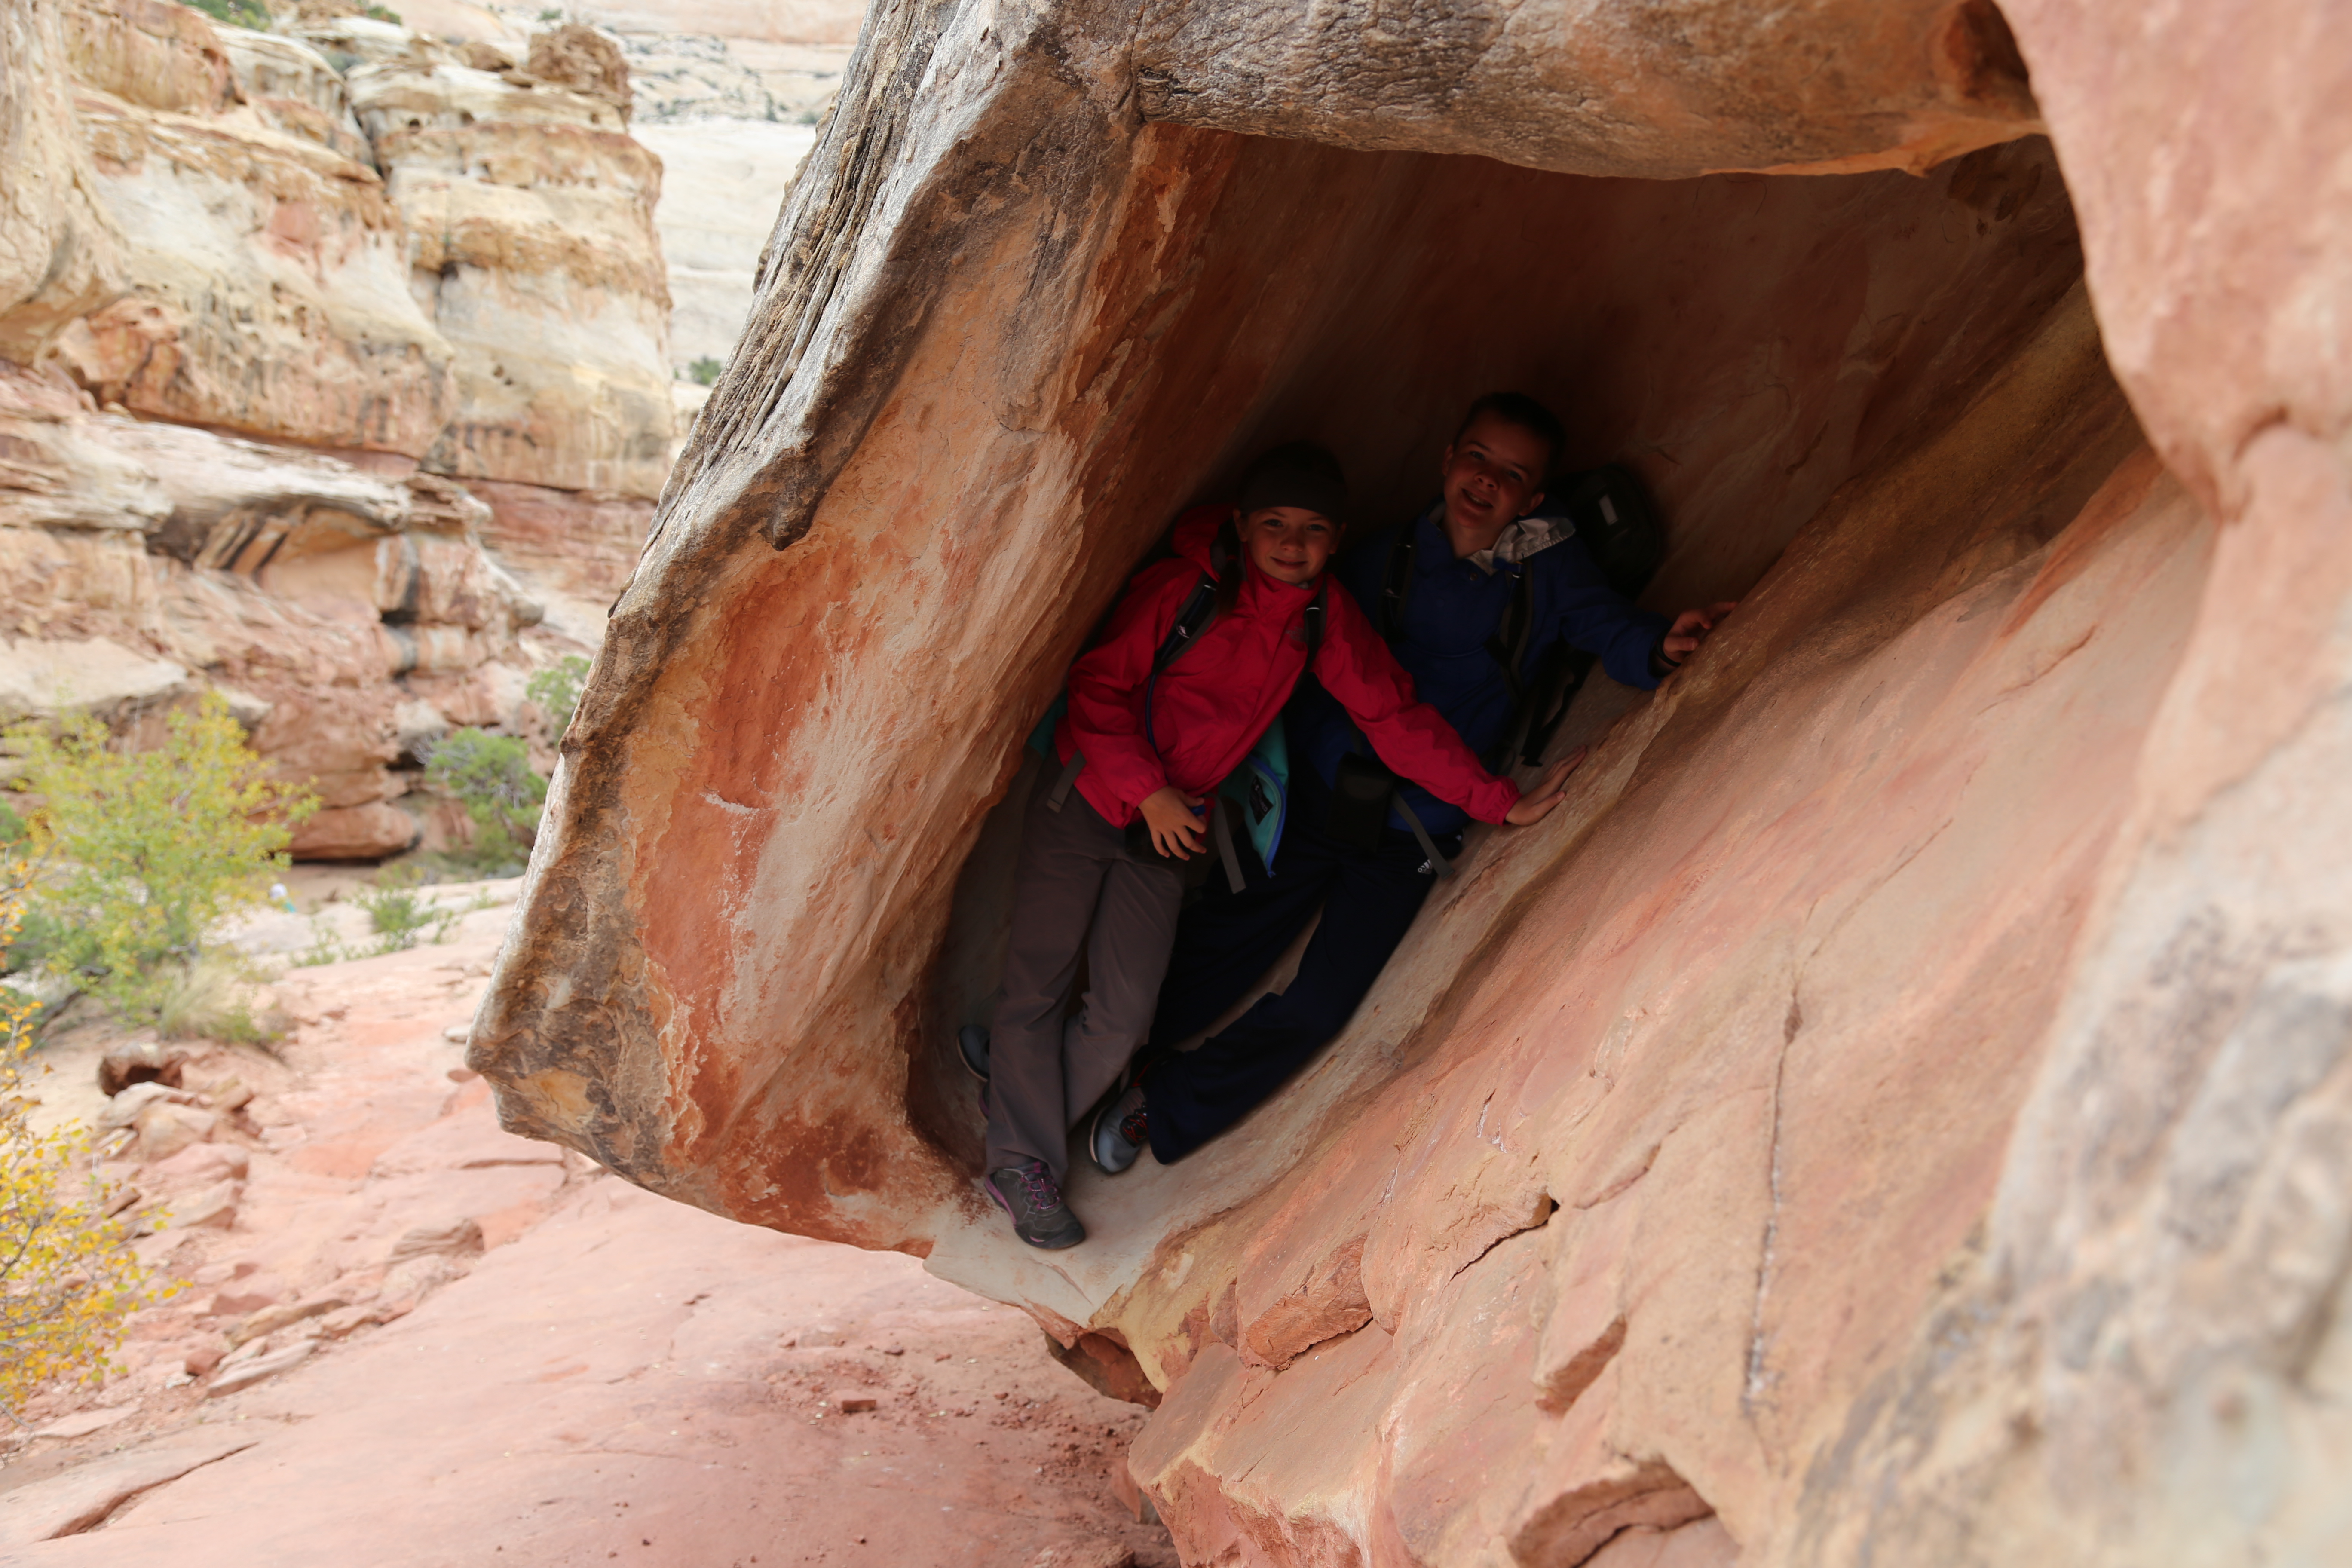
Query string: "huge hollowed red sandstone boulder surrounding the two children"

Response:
xmin=470 ymin=5 xmax=2352 ymax=1568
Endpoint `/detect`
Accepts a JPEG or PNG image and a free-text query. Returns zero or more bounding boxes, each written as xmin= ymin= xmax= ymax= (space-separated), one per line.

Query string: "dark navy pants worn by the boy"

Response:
xmin=1143 ymin=811 xmax=1461 ymax=1164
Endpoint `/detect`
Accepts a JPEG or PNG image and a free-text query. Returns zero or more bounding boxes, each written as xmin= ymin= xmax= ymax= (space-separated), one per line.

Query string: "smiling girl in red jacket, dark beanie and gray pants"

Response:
xmin=965 ymin=442 xmax=1566 ymax=1248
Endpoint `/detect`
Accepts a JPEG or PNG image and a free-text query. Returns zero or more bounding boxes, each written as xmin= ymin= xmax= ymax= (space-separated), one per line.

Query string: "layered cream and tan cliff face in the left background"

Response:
xmin=0 ymin=0 xmax=673 ymax=858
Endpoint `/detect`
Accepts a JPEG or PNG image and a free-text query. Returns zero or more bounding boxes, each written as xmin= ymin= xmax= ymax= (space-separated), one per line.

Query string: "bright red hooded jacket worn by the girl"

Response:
xmin=1054 ymin=505 xmax=1519 ymax=827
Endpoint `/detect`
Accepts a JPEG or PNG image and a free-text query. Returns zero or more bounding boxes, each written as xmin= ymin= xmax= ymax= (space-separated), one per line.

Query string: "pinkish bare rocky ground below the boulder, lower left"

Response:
xmin=0 ymin=886 xmax=1176 ymax=1568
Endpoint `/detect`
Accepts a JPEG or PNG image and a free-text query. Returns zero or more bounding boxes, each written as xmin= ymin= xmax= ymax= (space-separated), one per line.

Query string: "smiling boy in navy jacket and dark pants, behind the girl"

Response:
xmin=1089 ymin=392 xmax=1733 ymax=1173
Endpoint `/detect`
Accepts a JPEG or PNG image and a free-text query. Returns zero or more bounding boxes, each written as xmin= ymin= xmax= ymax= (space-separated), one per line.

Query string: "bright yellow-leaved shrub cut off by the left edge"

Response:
xmin=0 ymin=853 xmax=176 ymax=1420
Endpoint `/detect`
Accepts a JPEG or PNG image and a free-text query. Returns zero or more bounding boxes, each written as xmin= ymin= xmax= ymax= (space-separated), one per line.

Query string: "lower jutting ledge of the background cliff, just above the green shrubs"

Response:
xmin=0 ymin=367 xmax=543 ymax=858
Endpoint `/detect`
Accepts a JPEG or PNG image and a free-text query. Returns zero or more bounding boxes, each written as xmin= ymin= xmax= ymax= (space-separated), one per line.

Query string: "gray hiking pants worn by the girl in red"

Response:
xmin=988 ymin=771 xmax=1183 ymax=1182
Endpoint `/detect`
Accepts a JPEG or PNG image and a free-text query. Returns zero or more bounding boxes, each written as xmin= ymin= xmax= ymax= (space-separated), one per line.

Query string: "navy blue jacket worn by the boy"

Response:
xmin=1282 ymin=503 xmax=1670 ymax=835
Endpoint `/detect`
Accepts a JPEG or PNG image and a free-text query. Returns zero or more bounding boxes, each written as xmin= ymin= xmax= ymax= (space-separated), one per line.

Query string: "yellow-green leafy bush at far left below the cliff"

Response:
xmin=12 ymin=691 xmax=318 ymax=1023
